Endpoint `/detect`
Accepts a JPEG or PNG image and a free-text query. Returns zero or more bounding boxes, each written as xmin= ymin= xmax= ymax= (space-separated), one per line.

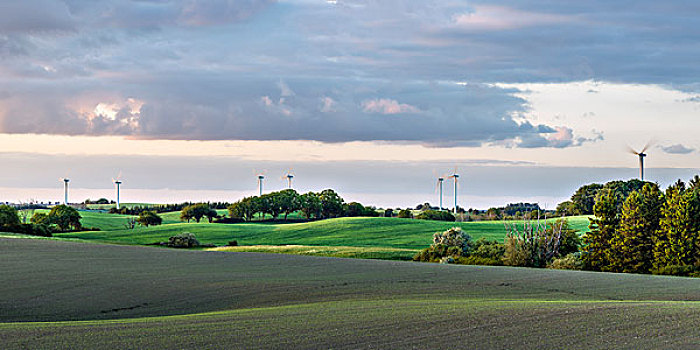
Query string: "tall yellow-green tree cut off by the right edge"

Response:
xmin=654 ymin=180 xmax=700 ymax=270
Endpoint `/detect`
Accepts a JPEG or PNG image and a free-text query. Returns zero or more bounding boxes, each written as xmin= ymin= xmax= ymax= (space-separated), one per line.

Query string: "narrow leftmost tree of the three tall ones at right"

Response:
xmin=583 ymin=189 xmax=620 ymax=271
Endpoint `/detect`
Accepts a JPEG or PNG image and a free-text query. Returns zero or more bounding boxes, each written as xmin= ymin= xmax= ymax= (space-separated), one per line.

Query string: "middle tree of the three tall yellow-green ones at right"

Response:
xmin=609 ymin=183 xmax=663 ymax=273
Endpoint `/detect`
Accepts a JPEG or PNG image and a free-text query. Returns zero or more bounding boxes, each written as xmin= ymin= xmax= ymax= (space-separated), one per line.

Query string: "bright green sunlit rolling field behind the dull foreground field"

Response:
xmin=55 ymin=213 xmax=588 ymax=259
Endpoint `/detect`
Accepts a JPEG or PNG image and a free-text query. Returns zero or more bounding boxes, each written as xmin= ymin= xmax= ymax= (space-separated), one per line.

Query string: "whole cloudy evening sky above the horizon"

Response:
xmin=0 ymin=0 xmax=700 ymax=209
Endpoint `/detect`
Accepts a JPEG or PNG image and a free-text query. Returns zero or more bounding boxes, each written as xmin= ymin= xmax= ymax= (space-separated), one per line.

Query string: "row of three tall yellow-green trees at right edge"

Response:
xmin=582 ymin=176 xmax=700 ymax=275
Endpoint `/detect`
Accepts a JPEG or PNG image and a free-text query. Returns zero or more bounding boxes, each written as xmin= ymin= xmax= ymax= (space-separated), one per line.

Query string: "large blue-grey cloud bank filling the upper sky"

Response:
xmin=0 ymin=0 xmax=700 ymax=147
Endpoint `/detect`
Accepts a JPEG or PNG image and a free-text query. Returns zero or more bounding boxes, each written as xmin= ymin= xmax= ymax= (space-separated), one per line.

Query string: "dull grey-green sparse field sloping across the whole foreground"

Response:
xmin=0 ymin=238 xmax=700 ymax=349
